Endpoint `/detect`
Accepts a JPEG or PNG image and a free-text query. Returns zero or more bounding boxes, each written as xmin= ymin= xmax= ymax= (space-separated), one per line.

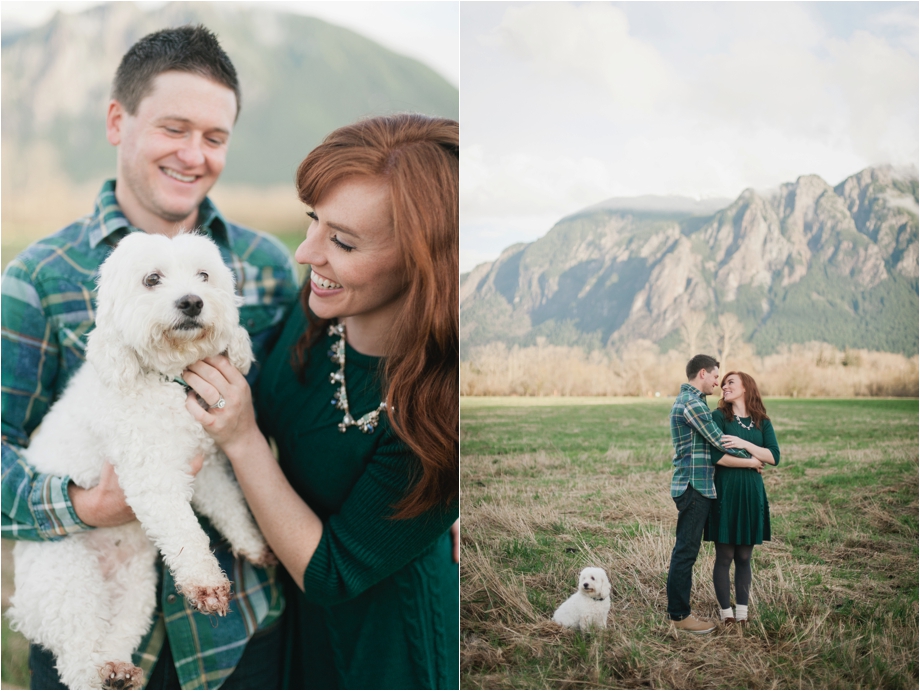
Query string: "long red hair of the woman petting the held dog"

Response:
xmin=294 ymin=114 xmax=460 ymax=518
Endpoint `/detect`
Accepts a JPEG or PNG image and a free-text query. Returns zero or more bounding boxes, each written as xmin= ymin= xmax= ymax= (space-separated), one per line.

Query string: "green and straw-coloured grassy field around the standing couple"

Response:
xmin=461 ymin=399 xmax=918 ymax=689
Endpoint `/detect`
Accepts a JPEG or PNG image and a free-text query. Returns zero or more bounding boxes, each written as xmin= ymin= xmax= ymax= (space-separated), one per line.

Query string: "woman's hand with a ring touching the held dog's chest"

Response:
xmin=182 ymin=355 xmax=261 ymax=460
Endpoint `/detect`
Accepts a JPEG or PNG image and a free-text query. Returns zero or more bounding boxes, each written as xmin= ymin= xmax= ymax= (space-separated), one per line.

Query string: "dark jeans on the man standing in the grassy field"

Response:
xmin=668 ymin=485 xmax=714 ymax=621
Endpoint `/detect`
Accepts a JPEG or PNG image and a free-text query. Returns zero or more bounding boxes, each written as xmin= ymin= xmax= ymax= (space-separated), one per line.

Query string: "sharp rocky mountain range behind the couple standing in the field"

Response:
xmin=460 ymin=166 xmax=920 ymax=356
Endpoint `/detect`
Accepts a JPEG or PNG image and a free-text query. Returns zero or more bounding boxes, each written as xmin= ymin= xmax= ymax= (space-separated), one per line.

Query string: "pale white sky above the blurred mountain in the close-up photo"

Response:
xmin=0 ymin=0 xmax=459 ymax=86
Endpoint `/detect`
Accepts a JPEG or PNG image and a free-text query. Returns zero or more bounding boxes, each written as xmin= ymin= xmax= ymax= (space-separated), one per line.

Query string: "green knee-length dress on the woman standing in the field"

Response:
xmin=704 ymin=410 xmax=779 ymax=545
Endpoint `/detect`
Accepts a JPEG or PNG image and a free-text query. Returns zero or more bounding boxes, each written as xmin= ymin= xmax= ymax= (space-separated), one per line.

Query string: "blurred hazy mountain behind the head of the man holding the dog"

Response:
xmin=2 ymin=2 xmax=459 ymax=193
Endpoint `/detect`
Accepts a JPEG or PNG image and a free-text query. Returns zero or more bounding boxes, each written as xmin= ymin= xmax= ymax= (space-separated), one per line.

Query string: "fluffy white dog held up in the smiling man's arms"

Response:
xmin=9 ymin=233 xmax=273 ymax=689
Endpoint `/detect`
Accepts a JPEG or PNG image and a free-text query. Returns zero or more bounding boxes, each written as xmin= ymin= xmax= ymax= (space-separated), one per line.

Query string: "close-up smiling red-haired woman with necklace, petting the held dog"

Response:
xmin=184 ymin=115 xmax=459 ymax=688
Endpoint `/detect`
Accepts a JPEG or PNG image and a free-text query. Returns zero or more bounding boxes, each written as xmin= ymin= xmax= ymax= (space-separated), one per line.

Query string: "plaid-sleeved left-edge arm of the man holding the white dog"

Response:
xmin=0 ymin=258 xmax=89 ymax=540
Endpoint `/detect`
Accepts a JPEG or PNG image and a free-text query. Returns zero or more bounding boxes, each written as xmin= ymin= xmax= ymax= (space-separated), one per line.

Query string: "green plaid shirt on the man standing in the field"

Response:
xmin=671 ymin=384 xmax=751 ymax=499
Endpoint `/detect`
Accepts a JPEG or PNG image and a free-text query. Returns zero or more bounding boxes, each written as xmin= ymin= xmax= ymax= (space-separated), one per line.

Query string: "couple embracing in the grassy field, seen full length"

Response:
xmin=667 ymin=355 xmax=779 ymax=634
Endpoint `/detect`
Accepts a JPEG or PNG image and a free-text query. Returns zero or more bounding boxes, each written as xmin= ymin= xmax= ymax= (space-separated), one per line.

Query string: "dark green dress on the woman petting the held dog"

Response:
xmin=255 ymin=305 xmax=460 ymax=689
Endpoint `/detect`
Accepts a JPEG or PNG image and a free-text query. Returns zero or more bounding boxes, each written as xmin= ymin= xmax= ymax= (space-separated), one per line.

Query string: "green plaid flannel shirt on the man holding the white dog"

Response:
xmin=0 ymin=180 xmax=298 ymax=689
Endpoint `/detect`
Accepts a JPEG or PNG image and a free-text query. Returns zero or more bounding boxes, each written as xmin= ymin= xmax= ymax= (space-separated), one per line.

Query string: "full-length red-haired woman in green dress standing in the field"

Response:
xmin=705 ymin=372 xmax=779 ymax=624
